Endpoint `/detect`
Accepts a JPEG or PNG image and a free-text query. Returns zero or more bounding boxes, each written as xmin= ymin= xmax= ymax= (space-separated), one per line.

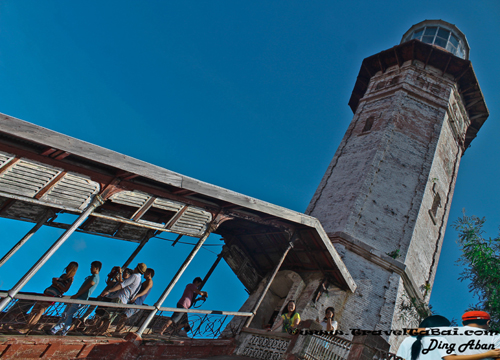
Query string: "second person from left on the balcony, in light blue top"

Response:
xmin=49 ymin=261 xmax=102 ymax=336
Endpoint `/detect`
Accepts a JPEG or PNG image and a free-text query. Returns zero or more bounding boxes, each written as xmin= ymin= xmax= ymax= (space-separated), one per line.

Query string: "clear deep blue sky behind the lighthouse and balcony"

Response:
xmin=0 ymin=0 xmax=500 ymax=324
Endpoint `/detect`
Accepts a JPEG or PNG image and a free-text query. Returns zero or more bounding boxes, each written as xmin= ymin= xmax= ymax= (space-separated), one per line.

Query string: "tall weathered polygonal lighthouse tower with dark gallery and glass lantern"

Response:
xmin=306 ymin=20 xmax=488 ymax=345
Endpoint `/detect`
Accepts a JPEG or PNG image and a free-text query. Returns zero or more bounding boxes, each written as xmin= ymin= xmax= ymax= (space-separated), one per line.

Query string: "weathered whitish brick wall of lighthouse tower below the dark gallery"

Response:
xmin=306 ymin=62 xmax=468 ymax=345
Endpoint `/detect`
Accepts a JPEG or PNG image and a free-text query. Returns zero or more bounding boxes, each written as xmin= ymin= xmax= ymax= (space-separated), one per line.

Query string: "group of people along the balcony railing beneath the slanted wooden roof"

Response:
xmin=9 ymin=261 xmax=213 ymax=336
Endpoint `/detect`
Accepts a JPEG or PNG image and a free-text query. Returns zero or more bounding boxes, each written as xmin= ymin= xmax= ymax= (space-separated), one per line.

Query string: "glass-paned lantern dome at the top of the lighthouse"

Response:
xmin=401 ymin=20 xmax=469 ymax=59
